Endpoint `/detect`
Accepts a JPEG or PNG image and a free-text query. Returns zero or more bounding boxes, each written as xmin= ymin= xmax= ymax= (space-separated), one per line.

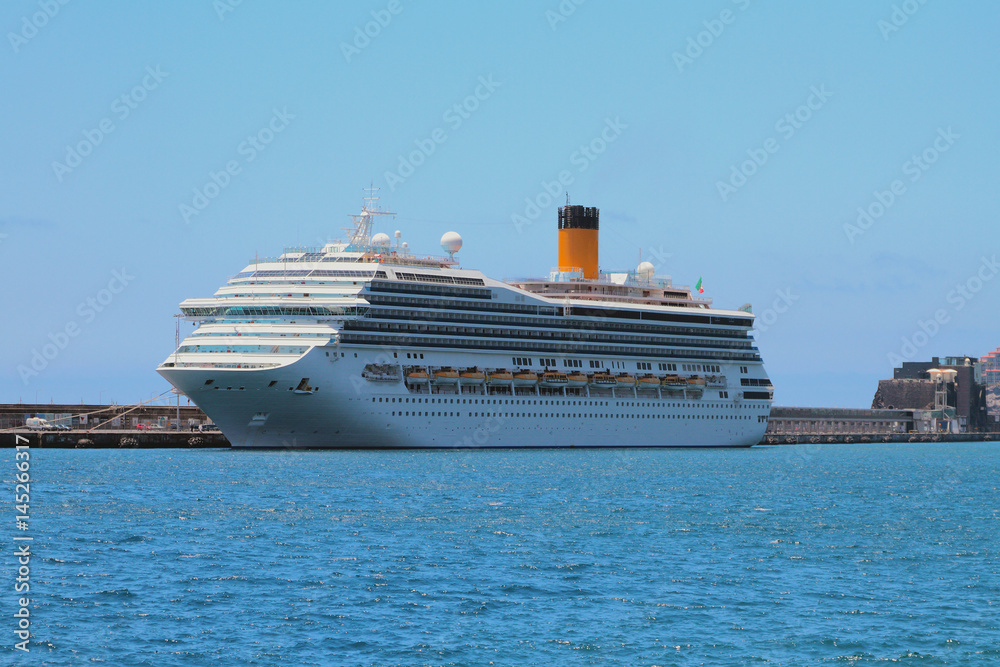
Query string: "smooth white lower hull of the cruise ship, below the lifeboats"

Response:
xmin=160 ymin=345 xmax=770 ymax=449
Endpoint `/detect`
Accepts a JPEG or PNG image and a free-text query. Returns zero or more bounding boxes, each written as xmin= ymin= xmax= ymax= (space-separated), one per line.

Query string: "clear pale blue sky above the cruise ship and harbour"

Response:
xmin=0 ymin=0 xmax=1000 ymax=407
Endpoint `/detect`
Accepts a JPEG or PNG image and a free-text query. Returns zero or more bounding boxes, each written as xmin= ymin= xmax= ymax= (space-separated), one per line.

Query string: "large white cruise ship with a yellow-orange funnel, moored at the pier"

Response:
xmin=157 ymin=193 xmax=773 ymax=449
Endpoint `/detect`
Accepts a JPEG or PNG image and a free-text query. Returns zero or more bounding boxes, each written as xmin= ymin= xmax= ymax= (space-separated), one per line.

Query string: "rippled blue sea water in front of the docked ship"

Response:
xmin=7 ymin=443 xmax=1000 ymax=667
